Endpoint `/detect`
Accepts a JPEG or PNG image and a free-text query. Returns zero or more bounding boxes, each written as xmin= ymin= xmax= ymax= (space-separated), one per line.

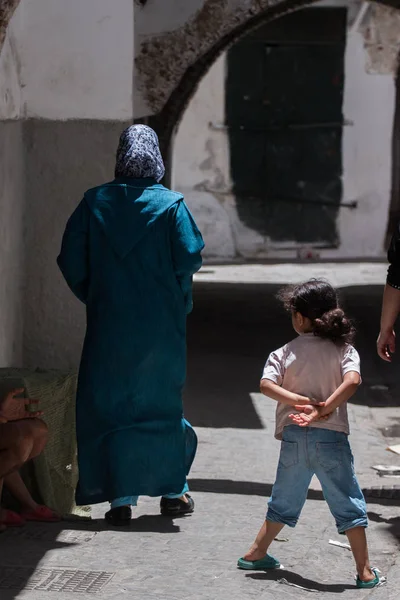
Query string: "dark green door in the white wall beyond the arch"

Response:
xmin=226 ymin=8 xmax=346 ymax=246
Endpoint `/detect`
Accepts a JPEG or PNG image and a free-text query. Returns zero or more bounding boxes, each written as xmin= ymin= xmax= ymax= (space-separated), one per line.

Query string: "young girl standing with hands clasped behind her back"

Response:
xmin=238 ymin=280 xmax=380 ymax=588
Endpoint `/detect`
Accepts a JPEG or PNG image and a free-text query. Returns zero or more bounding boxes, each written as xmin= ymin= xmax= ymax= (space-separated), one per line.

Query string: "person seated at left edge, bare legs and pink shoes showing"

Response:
xmin=0 ymin=389 xmax=60 ymax=531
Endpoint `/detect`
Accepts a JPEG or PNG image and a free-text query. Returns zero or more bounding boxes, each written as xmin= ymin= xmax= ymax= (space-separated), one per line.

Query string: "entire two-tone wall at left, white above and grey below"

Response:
xmin=0 ymin=0 xmax=134 ymax=368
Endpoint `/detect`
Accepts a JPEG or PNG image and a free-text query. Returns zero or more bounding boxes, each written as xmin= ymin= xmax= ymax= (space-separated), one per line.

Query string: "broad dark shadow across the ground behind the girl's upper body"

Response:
xmin=185 ymin=283 xmax=400 ymax=432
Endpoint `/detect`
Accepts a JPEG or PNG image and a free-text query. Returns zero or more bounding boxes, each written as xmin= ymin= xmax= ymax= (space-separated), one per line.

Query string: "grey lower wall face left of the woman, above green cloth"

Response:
xmin=24 ymin=120 xmax=127 ymax=368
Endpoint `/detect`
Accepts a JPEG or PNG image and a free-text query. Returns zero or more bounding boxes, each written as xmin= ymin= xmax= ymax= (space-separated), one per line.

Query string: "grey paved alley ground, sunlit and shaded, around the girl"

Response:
xmin=0 ymin=265 xmax=400 ymax=600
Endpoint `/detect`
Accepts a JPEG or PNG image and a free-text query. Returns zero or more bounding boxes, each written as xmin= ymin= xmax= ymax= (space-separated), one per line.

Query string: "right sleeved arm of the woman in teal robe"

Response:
xmin=171 ymin=200 xmax=204 ymax=313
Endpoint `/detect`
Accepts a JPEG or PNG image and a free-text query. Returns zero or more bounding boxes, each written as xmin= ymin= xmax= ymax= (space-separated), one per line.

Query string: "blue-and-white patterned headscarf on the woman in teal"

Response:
xmin=115 ymin=125 xmax=165 ymax=181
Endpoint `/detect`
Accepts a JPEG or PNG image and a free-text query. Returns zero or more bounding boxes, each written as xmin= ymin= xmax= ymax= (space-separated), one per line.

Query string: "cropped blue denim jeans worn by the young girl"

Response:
xmin=266 ymin=425 xmax=368 ymax=533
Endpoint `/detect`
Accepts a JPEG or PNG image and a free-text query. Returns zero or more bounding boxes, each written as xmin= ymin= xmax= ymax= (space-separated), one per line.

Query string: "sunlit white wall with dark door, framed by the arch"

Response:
xmin=172 ymin=2 xmax=394 ymax=261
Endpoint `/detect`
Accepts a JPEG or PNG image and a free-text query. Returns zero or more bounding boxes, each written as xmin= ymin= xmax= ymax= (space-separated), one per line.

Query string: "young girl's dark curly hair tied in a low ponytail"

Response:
xmin=278 ymin=279 xmax=356 ymax=345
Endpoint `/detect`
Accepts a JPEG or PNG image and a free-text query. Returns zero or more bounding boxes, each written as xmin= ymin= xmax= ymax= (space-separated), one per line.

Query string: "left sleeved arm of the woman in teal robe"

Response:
xmin=57 ymin=200 xmax=89 ymax=304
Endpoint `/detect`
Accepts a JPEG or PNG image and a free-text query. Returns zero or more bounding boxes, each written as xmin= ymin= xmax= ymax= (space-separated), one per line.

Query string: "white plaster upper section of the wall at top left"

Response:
xmin=11 ymin=0 xmax=134 ymax=120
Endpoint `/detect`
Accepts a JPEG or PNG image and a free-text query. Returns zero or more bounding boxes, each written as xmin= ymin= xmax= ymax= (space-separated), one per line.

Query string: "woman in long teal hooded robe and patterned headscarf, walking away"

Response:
xmin=58 ymin=125 xmax=204 ymax=524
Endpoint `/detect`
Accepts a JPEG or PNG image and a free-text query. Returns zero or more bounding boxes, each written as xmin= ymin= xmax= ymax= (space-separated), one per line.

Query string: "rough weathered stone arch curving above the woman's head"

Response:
xmin=136 ymin=0 xmax=400 ymax=169
